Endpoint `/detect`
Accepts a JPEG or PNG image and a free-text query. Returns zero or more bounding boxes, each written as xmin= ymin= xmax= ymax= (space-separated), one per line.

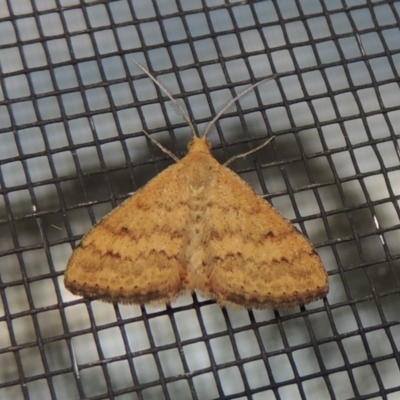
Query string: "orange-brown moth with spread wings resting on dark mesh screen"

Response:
xmin=64 ymin=62 xmax=329 ymax=309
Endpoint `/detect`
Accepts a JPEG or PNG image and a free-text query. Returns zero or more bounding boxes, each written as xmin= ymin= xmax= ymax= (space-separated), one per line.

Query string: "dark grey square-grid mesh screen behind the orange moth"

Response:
xmin=0 ymin=0 xmax=400 ymax=400
